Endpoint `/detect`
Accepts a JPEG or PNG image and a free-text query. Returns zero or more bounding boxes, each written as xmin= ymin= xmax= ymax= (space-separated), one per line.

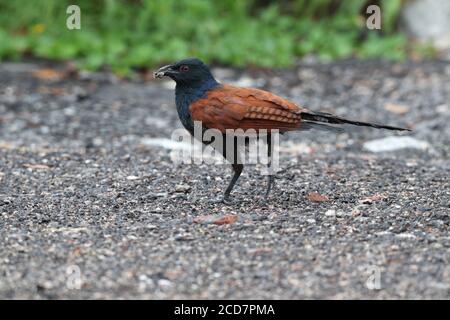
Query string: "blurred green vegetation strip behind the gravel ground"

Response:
xmin=0 ymin=0 xmax=414 ymax=73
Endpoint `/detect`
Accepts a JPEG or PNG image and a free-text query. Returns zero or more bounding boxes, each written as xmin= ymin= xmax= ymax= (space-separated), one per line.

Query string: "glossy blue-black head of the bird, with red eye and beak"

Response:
xmin=154 ymin=58 xmax=217 ymax=86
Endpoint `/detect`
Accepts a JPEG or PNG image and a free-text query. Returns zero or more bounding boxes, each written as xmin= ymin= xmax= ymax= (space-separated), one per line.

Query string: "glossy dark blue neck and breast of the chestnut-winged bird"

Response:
xmin=175 ymin=78 xmax=220 ymax=133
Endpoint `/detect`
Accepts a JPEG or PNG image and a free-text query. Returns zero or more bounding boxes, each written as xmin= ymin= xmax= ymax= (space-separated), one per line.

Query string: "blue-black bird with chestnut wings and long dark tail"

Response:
xmin=154 ymin=58 xmax=411 ymax=204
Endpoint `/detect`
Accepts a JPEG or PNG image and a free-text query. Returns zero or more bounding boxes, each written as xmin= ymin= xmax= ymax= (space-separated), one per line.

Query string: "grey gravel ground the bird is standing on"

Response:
xmin=0 ymin=60 xmax=450 ymax=299
